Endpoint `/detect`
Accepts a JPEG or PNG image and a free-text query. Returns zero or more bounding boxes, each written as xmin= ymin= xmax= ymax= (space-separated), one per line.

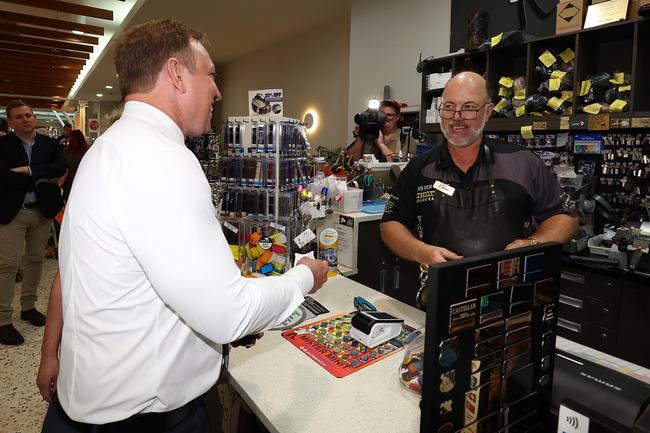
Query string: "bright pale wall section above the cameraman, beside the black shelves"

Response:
xmin=348 ymin=0 xmax=451 ymax=130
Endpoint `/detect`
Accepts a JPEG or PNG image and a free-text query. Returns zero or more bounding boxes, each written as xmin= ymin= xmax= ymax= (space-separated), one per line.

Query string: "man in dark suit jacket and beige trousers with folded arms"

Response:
xmin=0 ymin=100 xmax=67 ymax=345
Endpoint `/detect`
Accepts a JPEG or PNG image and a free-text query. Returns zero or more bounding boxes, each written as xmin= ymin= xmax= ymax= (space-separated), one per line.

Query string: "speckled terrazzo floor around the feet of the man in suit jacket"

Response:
xmin=0 ymin=259 xmax=58 ymax=433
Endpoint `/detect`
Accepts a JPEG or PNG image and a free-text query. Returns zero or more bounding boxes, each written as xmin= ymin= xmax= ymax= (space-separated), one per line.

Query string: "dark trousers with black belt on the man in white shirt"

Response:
xmin=41 ymin=394 xmax=210 ymax=433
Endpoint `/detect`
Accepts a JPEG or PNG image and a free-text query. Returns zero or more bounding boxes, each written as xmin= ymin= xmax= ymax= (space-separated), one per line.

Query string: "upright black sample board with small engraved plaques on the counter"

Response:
xmin=420 ymin=243 xmax=561 ymax=433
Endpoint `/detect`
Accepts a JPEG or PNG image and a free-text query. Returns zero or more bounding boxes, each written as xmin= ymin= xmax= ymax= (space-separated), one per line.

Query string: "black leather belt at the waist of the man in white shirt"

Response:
xmin=52 ymin=394 xmax=205 ymax=433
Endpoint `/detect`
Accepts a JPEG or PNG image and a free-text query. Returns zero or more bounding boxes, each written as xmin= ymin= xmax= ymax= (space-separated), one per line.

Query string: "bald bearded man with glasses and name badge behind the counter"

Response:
xmin=380 ymin=72 xmax=578 ymax=264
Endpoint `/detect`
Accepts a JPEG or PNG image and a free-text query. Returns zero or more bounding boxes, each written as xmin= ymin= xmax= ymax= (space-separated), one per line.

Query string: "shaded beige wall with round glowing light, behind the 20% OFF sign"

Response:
xmin=218 ymin=13 xmax=352 ymax=148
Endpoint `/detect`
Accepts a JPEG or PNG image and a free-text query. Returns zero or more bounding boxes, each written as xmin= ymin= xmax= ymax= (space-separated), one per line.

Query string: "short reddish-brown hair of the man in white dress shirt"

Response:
xmin=115 ymin=19 xmax=205 ymax=98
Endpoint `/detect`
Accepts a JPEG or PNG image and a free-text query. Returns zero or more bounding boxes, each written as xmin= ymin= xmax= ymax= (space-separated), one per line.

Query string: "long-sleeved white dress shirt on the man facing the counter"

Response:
xmin=57 ymin=101 xmax=313 ymax=424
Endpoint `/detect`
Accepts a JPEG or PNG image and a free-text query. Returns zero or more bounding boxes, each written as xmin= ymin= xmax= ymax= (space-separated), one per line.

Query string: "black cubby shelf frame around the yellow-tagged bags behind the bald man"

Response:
xmin=420 ymin=20 xmax=650 ymax=133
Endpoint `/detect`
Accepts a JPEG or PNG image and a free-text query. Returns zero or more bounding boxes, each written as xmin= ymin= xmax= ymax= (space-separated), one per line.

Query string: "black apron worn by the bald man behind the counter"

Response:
xmin=421 ymin=144 xmax=530 ymax=257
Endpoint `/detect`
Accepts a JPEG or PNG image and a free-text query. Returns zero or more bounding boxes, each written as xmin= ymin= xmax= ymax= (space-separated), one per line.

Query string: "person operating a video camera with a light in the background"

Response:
xmin=348 ymin=100 xmax=401 ymax=162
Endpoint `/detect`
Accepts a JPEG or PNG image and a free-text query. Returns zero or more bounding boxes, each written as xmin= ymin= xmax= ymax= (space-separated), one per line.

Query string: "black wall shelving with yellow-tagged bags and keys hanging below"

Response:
xmin=420 ymin=20 xmax=650 ymax=223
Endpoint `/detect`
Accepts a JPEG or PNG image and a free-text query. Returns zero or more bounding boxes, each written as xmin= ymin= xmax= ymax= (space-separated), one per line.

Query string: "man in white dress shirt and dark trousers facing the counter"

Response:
xmin=38 ymin=20 xmax=327 ymax=433
